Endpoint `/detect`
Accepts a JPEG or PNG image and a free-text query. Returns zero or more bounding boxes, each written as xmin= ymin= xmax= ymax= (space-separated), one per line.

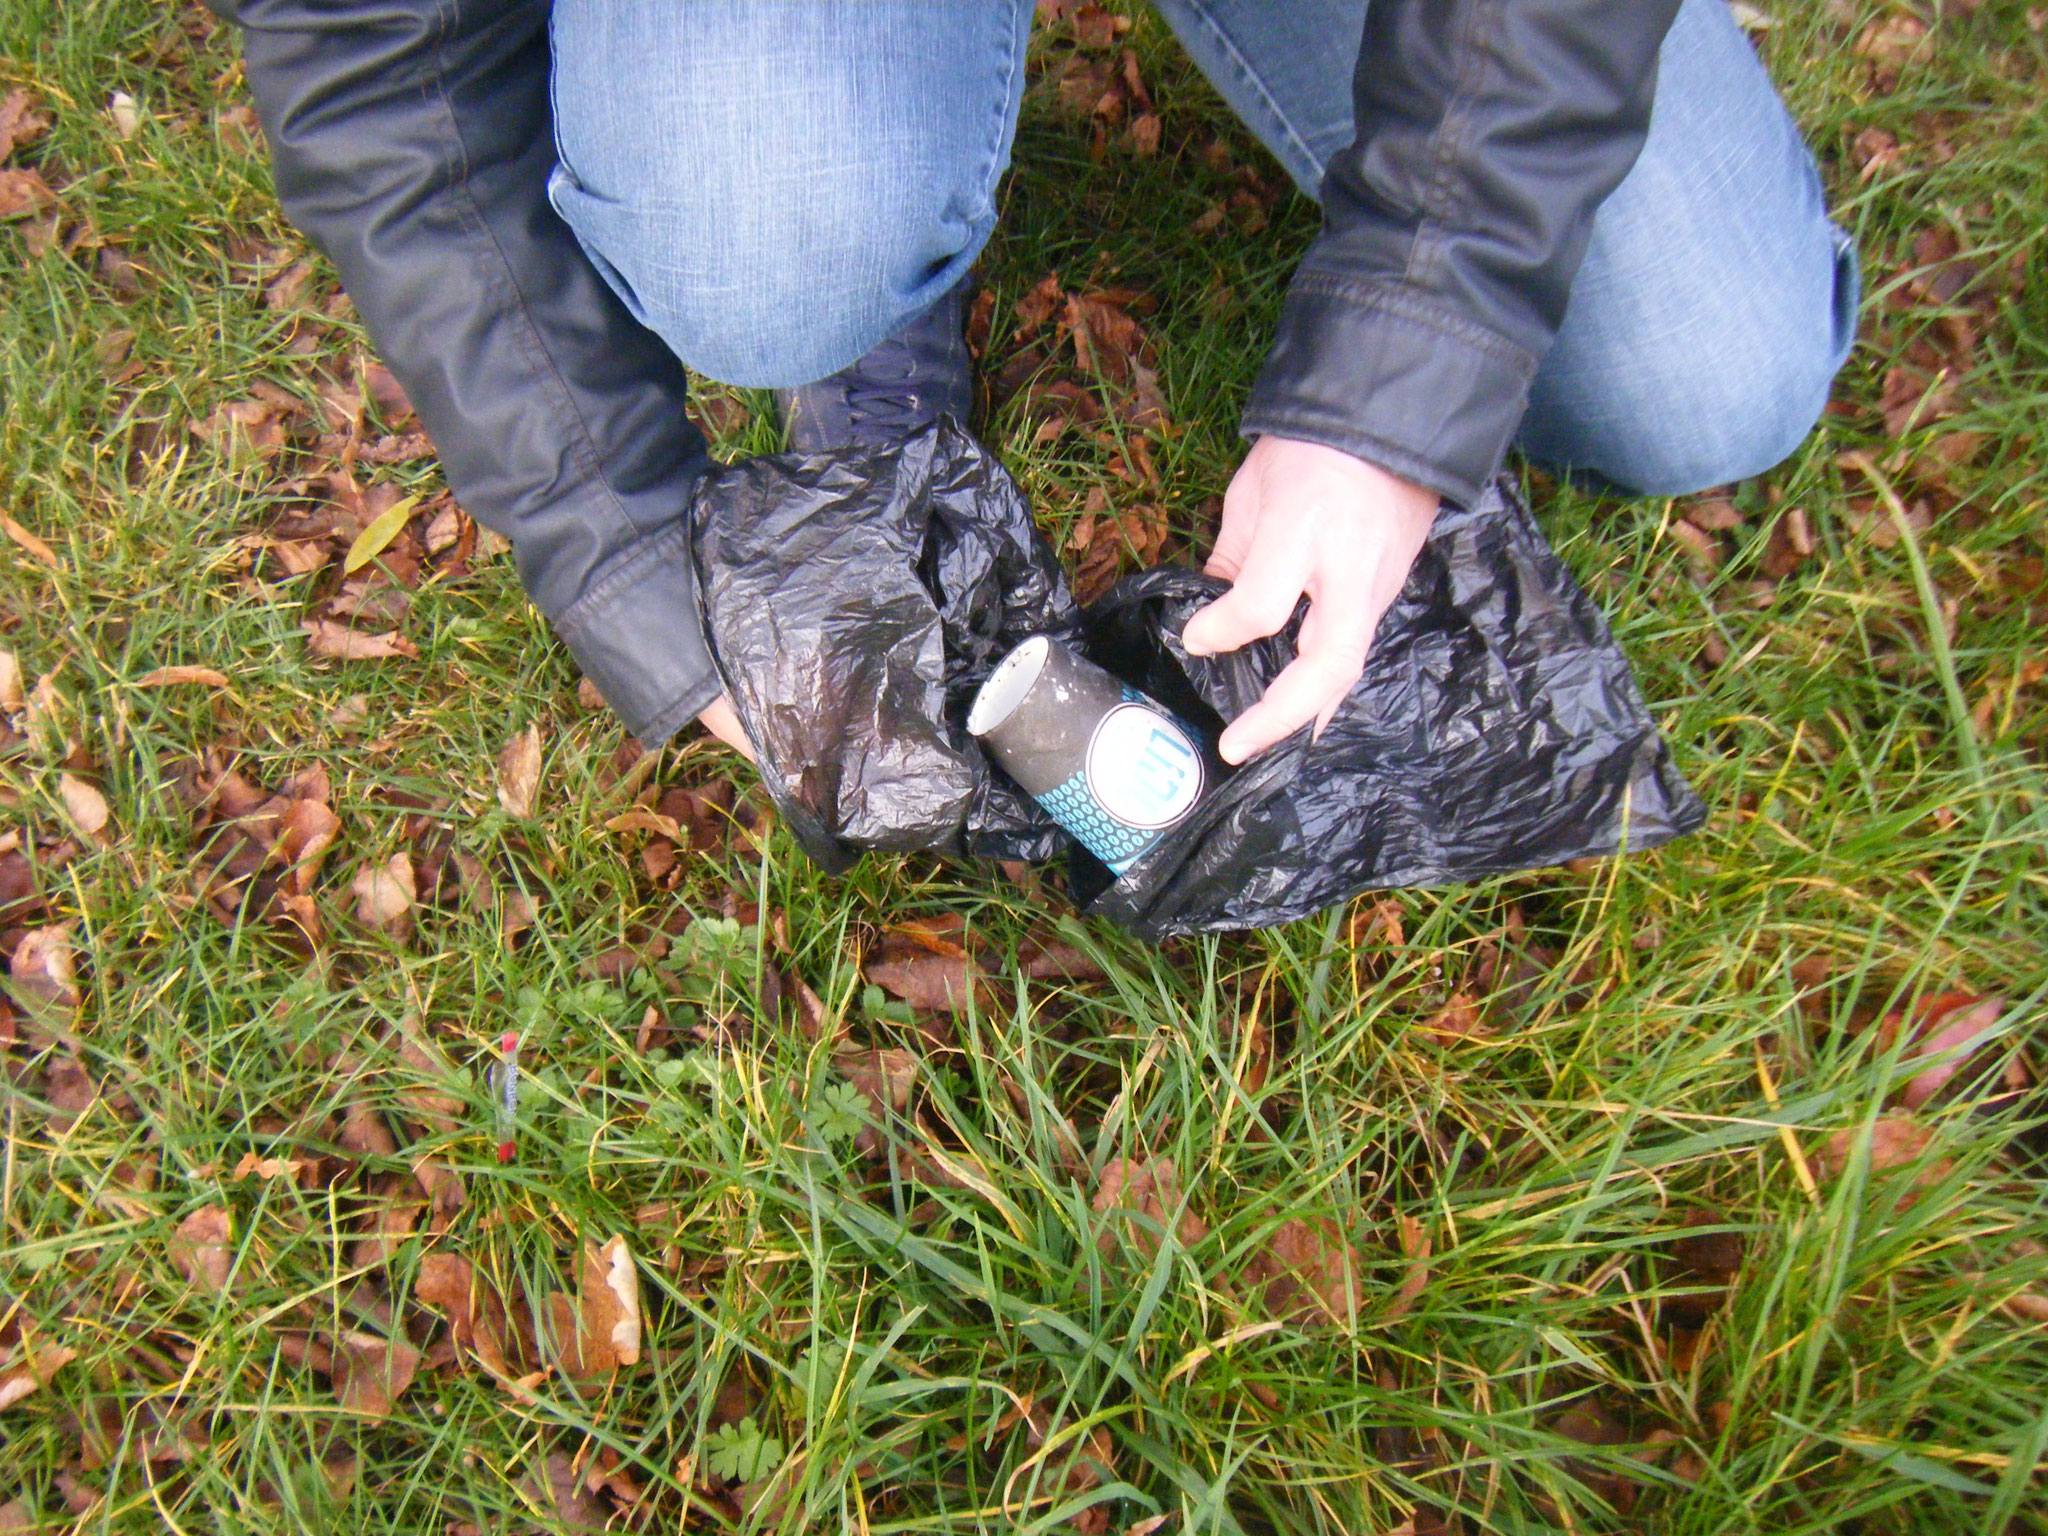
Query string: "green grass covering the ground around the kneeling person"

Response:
xmin=0 ymin=0 xmax=2048 ymax=1536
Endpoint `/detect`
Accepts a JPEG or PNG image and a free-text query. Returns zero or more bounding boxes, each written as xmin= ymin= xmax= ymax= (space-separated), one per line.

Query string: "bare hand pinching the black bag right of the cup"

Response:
xmin=1182 ymin=436 xmax=1438 ymax=762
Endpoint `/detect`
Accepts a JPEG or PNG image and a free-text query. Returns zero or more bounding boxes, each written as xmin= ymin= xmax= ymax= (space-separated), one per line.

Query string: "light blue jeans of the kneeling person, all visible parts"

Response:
xmin=549 ymin=0 xmax=1858 ymax=496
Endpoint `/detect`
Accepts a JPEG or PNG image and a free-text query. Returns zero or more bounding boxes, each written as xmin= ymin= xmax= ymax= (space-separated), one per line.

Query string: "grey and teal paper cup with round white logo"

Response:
xmin=967 ymin=635 xmax=1208 ymax=874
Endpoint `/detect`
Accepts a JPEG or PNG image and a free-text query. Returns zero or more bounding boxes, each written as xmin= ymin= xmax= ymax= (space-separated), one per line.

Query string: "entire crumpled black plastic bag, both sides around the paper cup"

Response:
xmin=692 ymin=422 xmax=1706 ymax=940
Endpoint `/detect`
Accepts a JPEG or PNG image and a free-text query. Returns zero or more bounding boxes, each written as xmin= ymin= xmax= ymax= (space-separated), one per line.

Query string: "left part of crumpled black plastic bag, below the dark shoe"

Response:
xmin=690 ymin=420 xmax=1079 ymax=870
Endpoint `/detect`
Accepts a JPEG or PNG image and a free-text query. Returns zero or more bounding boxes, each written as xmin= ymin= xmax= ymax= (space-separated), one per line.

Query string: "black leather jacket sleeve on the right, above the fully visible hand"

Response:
xmin=1243 ymin=0 xmax=1677 ymax=506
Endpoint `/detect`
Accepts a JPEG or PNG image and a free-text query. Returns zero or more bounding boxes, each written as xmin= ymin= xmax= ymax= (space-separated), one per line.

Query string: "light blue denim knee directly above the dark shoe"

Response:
xmin=549 ymin=0 xmax=1032 ymax=387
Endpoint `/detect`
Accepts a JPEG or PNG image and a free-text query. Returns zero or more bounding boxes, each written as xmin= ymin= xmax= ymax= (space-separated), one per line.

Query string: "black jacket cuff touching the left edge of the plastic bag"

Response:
xmin=555 ymin=522 xmax=725 ymax=748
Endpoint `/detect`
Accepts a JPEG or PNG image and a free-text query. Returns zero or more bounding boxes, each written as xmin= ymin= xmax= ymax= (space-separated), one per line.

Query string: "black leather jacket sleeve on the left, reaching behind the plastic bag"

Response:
xmin=217 ymin=0 xmax=719 ymax=741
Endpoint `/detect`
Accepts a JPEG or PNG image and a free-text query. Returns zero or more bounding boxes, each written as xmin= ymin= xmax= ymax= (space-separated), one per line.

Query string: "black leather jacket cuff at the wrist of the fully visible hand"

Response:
xmin=1241 ymin=272 xmax=1536 ymax=506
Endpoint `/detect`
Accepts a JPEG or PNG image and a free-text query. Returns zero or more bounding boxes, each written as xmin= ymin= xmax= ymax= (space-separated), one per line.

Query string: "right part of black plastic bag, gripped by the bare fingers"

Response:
xmin=1069 ymin=481 xmax=1706 ymax=940
